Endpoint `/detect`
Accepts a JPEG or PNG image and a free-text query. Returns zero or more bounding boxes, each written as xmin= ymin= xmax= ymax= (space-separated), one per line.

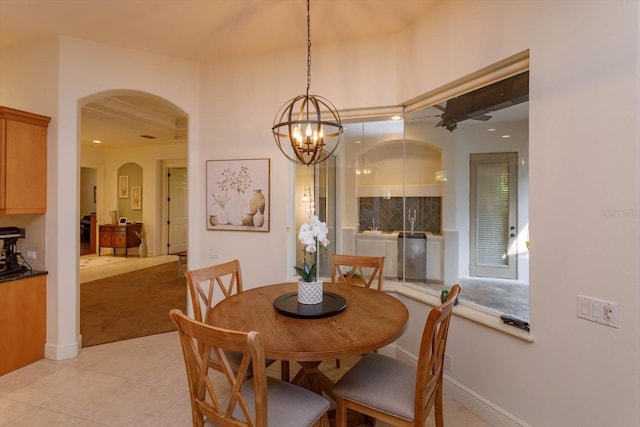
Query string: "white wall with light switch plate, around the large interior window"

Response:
xmin=400 ymin=1 xmax=640 ymax=426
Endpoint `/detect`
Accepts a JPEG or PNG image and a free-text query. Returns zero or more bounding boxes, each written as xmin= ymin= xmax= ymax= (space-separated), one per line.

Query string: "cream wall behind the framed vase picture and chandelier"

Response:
xmin=195 ymin=37 xmax=398 ymax=288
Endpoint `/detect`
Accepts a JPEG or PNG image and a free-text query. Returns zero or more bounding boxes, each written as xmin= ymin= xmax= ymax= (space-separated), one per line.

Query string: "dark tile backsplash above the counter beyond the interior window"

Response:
xmin=358 ymin=197 xmax=442 ymax=234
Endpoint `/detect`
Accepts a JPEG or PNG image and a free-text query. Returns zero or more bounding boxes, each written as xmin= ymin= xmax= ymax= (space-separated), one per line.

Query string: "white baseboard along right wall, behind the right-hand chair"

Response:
xmin=396 ymin=346 xmax=531 ymax=427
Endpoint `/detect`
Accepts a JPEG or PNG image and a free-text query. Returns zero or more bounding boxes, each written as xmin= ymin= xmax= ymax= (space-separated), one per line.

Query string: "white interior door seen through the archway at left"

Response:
xmin=167 ymin=168 xmax=188 ymax=254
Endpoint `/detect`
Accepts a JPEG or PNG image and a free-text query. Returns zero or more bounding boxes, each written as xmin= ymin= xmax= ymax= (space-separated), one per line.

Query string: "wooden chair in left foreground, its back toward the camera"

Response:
xmin=169 ymin=309 xmax=329 ymax=427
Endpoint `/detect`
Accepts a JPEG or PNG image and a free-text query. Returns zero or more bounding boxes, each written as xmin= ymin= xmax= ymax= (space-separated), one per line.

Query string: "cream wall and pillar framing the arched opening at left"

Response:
xmin=0 ymin=37 xmax=199 ymax=359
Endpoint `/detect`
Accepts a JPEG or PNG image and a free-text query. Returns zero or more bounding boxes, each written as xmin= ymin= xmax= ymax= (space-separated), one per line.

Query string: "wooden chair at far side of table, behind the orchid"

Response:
xmin=331 ymin=254 xmax=384 ymax=369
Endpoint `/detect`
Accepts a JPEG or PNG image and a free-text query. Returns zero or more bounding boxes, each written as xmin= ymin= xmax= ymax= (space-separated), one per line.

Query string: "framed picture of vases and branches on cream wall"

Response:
xmin=207 ymin=159 xmax=270 ymax=231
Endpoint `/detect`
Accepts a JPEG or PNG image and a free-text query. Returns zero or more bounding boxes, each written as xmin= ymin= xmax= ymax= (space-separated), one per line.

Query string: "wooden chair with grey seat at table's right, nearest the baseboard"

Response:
xmin=333 ymin=284 xmax=460 ymax=427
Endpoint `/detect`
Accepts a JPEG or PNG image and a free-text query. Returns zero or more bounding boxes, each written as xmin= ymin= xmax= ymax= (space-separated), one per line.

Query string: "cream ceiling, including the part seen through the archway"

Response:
xmin=0 ymin=0 xmax=442 ymax=148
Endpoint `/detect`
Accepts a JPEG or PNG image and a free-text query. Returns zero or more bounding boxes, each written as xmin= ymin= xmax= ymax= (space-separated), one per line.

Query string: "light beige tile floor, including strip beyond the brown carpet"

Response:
xmin=0 ymin=257 xmax=490 ymax=427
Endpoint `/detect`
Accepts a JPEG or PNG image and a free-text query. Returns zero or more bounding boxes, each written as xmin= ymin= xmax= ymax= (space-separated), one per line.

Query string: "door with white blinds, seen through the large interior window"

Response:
xmin=469 ymin=153 xmax=518 ymax=279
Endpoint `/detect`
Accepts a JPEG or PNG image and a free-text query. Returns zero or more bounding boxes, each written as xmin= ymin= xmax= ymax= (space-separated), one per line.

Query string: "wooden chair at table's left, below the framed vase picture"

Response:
xmin=184 ymin=259 xmax=289 ymax=381
